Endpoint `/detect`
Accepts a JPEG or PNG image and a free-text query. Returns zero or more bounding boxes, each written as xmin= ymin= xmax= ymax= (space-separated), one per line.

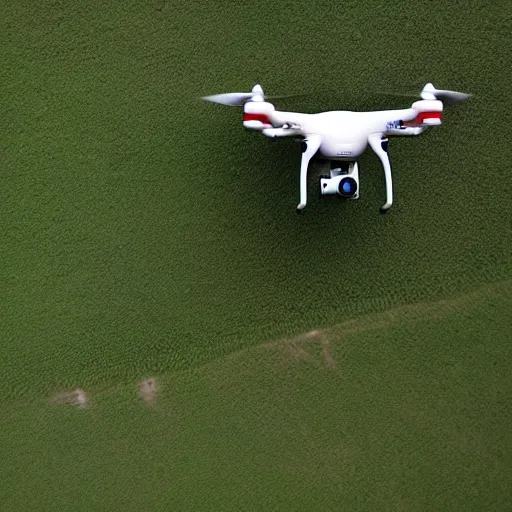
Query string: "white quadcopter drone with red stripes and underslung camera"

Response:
xmin=202 ymin=83 xmax=471 ymax=213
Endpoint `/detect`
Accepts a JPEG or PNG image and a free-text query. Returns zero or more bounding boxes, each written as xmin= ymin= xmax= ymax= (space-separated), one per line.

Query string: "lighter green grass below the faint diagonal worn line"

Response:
xmin=0 ymin=282 xmax=512 ymax=511
